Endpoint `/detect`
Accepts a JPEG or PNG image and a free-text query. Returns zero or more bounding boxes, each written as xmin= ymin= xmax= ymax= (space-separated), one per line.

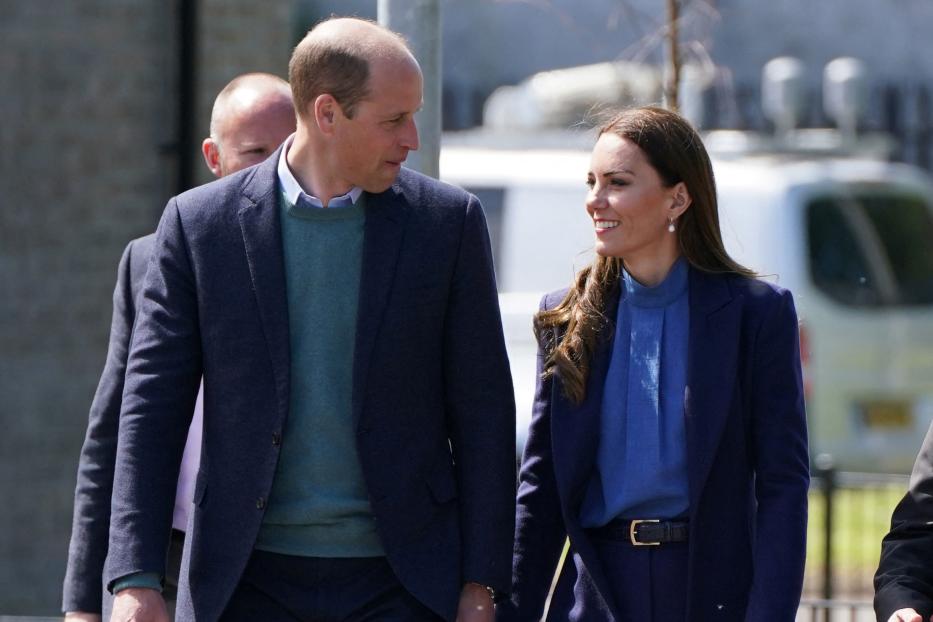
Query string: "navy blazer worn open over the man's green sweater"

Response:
xmin=107 ymin=148 xmax=515 ymax=620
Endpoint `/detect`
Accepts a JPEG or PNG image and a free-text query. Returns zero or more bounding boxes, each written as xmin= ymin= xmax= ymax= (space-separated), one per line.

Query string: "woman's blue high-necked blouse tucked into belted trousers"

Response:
xmin=580 ymin=257 xmax=690 ymax=527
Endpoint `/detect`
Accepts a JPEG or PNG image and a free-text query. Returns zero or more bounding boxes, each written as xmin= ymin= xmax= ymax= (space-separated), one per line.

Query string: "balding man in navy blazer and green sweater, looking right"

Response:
xmin=107 ymin=19 xmax=515 ymax=621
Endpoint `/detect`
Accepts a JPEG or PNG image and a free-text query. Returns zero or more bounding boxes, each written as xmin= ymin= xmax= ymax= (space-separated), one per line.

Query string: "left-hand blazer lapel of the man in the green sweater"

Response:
xmin=237 ymin=147 xmax=290 ymax=422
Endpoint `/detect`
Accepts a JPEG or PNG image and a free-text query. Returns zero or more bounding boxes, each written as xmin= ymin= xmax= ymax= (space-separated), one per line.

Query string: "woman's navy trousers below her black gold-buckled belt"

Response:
xmin=547 ymin=537 xmax=688 ymax=622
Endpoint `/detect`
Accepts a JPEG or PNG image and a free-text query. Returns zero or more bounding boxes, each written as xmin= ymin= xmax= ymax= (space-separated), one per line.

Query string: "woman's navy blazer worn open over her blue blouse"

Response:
xmin=498 ymin=268 xmax=809 ymax=622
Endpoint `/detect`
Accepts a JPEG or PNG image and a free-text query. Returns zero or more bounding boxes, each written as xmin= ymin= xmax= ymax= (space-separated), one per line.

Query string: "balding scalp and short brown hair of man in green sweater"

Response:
xmin=288 ymin=17 xmax=417 ymax=118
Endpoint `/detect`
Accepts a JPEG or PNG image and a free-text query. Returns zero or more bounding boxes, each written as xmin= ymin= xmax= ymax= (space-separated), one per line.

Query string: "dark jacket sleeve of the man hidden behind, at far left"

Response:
xmin=62 ymin=234 xmax=155 ymax=613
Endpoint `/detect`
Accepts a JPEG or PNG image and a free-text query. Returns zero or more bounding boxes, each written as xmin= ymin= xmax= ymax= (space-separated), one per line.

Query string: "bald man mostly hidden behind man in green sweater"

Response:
xmin=62 ymin=73 xmax=295 ymax=622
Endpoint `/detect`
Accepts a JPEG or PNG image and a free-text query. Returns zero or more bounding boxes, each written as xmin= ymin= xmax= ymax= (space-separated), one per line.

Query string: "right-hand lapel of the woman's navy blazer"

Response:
xmin=684 ymin=268 xmax=742 ymax=508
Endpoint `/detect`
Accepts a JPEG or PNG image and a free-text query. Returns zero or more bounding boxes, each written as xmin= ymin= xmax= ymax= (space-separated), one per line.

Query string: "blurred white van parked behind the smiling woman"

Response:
xmin=441 ymin=130 xmax=933 ymax=473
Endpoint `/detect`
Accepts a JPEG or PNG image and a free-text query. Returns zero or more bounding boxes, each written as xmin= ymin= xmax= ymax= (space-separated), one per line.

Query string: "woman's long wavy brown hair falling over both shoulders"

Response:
xmin=534 ymin=106 xmax=755 ymax=404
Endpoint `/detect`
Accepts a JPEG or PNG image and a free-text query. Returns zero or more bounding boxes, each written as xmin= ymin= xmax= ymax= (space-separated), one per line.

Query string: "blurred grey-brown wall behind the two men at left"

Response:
xmin=0 ymin=0 xmax=292 ymax=615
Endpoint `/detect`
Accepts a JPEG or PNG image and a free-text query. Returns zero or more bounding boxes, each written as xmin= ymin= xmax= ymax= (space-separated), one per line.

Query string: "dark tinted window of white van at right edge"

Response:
xmin=806 ymin=189 xmax=933 ymax=307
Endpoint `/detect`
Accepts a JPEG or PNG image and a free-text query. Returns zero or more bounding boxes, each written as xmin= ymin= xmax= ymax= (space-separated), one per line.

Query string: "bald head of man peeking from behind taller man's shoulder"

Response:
xmin=201 ymin=73 xmax=295 ymax=177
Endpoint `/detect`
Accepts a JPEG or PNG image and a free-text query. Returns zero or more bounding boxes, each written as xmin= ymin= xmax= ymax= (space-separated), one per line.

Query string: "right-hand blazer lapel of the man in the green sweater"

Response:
xmin=352 ymin=180 xmax=408 ymax=425
